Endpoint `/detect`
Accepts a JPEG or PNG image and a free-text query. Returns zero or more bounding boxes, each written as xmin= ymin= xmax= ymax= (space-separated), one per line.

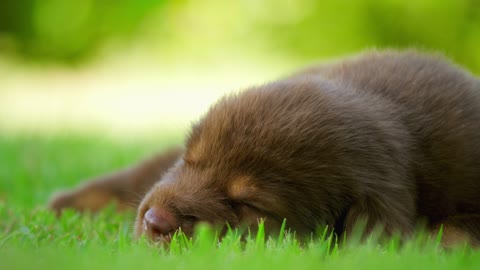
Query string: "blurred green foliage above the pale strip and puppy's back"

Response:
xmin=0 ymin=0 xmax=480 ymax=66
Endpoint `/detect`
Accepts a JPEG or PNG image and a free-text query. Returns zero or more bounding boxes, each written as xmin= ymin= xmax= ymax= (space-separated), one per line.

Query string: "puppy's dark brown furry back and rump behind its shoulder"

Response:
xmin=297 ymin=51 xmax=480 ymax=222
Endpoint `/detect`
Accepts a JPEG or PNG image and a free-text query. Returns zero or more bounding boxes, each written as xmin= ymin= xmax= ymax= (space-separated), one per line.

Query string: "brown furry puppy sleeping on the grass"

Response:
xmin=52 ymin=52 xmax=480 ymax=247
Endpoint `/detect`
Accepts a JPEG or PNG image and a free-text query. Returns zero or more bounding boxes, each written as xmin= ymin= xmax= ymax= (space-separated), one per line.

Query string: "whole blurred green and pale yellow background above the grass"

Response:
xmin=0 ymin=0 xmax=480 ymax=136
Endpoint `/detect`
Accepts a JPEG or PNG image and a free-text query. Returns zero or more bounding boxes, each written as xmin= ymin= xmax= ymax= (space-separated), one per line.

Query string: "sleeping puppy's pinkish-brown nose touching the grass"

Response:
xmin=143 ymin=207 xmax=176 ymax=240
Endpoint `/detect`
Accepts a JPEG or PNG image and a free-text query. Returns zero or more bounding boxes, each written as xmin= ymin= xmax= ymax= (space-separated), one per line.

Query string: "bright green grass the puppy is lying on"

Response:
xmin=0 ymin=135 xmax=480 ymax=270
